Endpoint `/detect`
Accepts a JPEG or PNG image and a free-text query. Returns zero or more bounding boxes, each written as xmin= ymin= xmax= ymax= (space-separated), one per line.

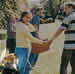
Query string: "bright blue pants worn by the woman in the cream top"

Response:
xmin=15 ymin=48 xmax=29 ymax=74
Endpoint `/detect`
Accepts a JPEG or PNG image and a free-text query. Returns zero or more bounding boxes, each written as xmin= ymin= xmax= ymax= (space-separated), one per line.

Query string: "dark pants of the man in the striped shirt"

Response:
xmin=60 ymin=49 xmax=75 ymax=74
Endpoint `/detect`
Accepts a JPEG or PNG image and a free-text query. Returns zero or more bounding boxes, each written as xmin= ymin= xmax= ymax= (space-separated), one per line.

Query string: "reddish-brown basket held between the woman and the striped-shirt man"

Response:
xmin=32 ymin=43 xmax=49 ymax=54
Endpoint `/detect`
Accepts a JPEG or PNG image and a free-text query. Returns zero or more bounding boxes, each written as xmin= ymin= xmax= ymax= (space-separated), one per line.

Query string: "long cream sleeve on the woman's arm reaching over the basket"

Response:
xmin=22 ymin=26 xmax=43 ymax=44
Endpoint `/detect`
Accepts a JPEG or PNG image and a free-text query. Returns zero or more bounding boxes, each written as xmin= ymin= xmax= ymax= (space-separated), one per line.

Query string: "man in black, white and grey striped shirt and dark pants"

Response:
xmin=50 ymin=2 xmax=75 ymax=74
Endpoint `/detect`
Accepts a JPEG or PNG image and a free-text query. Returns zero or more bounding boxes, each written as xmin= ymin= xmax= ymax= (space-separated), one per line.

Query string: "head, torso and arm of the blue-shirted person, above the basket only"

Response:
xmin=31 ymin=8 xmax=42 ymax=39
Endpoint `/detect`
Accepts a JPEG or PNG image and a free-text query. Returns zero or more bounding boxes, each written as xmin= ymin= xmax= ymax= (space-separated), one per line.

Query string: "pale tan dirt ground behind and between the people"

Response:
xmin=0 ymin=20 xmax=71 ymax=74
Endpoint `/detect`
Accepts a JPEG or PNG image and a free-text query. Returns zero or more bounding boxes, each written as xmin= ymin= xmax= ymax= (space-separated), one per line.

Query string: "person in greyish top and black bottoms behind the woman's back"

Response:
xmin=6 ymin=15 xmax=16 ymax=53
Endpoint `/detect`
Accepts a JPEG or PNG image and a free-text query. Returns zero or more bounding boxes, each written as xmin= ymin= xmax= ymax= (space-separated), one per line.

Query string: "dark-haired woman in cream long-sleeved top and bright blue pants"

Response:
xmin=15 ymin=12 xmax=46 ymax=74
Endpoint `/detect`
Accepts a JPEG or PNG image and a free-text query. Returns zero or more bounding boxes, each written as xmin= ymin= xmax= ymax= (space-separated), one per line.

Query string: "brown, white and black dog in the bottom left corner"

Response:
xmin=2 ymin=54 xmax=19 ymax=74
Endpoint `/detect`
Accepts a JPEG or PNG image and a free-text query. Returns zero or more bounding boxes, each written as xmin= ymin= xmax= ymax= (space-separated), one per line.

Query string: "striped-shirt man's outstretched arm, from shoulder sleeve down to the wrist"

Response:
xmin=49 ymin=16 xmax=71 ymax=44
